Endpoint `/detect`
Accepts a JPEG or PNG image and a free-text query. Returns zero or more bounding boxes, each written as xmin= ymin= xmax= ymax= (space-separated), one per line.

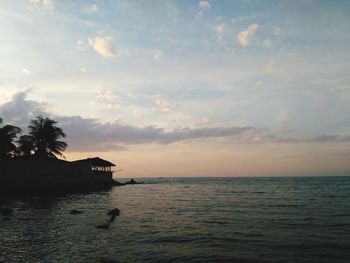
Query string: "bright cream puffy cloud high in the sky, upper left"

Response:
xmin=89 ymin=36 xmax=122 ymax=59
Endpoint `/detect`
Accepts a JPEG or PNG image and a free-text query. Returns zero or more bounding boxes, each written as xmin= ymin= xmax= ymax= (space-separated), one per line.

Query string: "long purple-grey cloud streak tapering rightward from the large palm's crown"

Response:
xmin=57 ymin=116 xmax=258 ymax=151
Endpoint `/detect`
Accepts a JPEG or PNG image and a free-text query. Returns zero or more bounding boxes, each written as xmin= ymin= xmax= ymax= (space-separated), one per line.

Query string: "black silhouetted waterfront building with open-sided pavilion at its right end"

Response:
xmin=0 ymin=157 xmax=121 ymax=192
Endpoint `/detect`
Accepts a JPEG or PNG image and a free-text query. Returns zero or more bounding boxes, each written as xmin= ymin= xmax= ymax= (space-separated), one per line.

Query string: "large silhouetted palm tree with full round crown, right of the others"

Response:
xmin=28 ymin=116 xmax=67 ymax=158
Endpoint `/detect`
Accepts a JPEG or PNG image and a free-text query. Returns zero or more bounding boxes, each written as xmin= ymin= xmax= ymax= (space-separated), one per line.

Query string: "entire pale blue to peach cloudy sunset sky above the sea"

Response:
xmin=0 ymin=0 xmax=350 ymax=177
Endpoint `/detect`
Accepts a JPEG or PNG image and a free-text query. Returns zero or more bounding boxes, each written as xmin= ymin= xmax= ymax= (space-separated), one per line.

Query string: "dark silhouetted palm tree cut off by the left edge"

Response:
xmin=0 ymin=118 xmax=22 ymax=159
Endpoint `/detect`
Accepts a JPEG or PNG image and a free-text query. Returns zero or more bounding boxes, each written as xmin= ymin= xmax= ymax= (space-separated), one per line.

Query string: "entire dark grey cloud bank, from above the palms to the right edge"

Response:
xmin=0 ymin=91 xmax=350 ymax=151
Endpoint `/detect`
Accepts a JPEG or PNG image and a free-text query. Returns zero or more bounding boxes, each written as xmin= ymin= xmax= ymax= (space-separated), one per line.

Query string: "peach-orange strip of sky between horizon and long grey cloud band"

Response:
xmin=66 ymin=143 xmax=348 ymax=178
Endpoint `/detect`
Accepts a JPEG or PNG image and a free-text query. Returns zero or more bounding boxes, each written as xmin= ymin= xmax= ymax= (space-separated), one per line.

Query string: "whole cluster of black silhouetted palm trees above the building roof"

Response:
xmin=0 ymin=116 xmax=67 ymax=159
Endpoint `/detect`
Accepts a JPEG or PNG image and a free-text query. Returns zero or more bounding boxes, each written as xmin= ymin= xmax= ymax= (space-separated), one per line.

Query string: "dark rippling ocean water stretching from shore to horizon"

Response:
xmin=0 ymin=177 xmax=350 ymax=263
